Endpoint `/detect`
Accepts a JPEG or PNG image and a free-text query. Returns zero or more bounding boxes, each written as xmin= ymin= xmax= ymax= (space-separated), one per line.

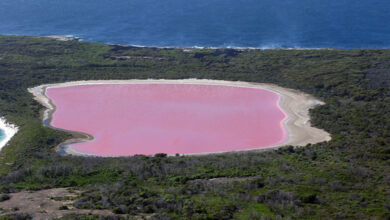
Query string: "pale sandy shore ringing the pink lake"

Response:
xmin=28 ymin=79 xmax=331 ymax=156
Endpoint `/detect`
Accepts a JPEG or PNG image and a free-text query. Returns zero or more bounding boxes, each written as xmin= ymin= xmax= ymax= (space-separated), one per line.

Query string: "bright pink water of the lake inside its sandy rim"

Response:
xmin=46 ymin=84 xmax=286 ymax=156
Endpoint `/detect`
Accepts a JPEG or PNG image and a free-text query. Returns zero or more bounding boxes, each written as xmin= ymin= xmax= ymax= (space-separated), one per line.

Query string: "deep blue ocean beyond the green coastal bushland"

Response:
xmin=0 ymin=0 xmax=390 ymax=48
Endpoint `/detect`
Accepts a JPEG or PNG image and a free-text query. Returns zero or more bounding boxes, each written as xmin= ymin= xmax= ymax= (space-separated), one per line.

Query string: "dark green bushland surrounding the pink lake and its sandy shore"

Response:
xmin=0 ymin=36 xmax=390 ymax=219
